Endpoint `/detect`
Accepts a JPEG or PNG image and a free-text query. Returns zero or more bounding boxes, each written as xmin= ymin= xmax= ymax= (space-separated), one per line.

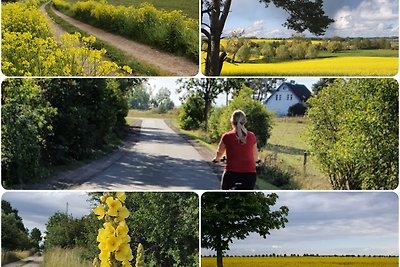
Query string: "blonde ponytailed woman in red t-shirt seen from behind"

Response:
xmin=213 ymin=110 xmax=258 ymax=190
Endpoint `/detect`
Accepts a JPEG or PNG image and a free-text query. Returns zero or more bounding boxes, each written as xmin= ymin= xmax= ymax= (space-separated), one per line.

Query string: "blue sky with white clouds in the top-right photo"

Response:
xmin=206 ymin=0 xmax=399 ymax=38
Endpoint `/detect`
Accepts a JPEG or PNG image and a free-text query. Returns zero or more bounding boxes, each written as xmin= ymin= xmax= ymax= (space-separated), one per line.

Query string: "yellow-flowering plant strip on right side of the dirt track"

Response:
xmin=58 ymin=0 xmax=199 ymax=61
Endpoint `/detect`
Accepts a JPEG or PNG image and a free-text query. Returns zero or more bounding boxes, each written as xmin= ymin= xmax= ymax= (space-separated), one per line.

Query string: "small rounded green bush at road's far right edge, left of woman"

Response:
xmin=178 ymin=95 xmax=205 ymax=130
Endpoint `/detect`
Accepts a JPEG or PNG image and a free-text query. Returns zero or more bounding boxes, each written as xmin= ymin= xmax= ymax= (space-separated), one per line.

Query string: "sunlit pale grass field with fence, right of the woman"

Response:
xmin=260 ymin=117 xmax=331 ymax=189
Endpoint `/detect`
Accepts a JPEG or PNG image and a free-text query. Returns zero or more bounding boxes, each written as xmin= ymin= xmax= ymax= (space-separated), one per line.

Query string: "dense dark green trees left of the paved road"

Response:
xmin=1 ymin=79 xmax=140 ymax=186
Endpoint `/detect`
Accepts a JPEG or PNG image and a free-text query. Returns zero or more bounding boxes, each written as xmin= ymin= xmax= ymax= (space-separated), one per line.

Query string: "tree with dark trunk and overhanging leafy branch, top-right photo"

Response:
xmin=201 ymin=0 xmax=333 ymax=76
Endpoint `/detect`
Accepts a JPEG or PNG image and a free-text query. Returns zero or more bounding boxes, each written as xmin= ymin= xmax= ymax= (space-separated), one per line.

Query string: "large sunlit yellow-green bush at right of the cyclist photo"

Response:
xmin=307 ymin=79 xmax=399 ymax=190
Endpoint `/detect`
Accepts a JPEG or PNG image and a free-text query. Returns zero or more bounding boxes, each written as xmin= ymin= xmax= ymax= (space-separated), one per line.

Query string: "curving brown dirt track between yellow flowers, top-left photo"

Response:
xmin=51 ymin=6 xmax=199 ymax=76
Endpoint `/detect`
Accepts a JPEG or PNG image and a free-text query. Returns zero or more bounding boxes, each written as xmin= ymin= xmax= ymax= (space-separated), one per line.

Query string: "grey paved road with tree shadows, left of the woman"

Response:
xmin=71 ymin=118 xmax=219 ymax=190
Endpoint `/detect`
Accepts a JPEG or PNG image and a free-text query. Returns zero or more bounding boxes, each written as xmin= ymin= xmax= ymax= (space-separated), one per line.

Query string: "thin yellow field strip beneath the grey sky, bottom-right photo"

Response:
xmin=201 ymin=257 xmax=399 ymax=267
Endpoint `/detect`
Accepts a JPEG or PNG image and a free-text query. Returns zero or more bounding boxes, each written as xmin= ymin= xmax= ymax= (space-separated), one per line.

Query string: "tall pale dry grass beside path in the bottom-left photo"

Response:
xmin=41 ymin=248 xmax=93 ymax=267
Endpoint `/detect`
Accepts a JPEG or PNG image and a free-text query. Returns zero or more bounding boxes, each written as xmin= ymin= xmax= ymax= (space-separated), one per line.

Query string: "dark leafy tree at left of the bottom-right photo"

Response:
xmin=201 ymin=192 xmax=289 ymax=267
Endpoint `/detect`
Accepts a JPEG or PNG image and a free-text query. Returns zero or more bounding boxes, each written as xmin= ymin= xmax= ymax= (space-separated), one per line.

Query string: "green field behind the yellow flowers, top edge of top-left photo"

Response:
xmin=61 ymin=0 xmax=199 ymax=20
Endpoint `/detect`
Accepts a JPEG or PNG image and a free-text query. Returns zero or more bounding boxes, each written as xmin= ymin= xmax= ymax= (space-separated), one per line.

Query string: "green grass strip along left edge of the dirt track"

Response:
xmin=45 ymin=3 xmax=167 ymax=76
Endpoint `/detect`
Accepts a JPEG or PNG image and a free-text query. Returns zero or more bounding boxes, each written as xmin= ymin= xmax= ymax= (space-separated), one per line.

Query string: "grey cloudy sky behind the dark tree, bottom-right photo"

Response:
xmin=202 ymin=192 xmax=399 ymax=255
